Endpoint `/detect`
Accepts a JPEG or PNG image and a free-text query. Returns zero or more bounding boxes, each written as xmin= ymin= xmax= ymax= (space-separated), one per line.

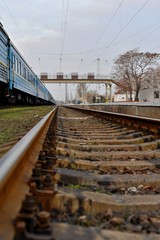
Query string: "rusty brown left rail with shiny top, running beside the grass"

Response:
xmin=0 ymin=108 xmax=57 ymax=239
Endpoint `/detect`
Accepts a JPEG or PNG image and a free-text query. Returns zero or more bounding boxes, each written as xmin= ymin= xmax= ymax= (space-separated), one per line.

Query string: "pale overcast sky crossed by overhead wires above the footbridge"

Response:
xmin=0 ymin=0 xmax=160 ymax=99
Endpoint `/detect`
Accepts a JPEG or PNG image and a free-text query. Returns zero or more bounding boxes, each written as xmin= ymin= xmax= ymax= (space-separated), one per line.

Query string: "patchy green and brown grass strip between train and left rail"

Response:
xmin=0 ymin=106 xmax=53 ymax=144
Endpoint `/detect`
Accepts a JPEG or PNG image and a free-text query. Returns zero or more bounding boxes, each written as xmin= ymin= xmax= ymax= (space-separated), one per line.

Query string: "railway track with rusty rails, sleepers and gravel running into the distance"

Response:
xmin=0 ymin=107 xmax=160 ymax=240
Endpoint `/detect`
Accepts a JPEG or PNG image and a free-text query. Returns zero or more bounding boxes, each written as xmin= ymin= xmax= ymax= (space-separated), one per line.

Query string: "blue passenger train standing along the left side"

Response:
xmin=0 ymin=23 xmax=56 ymax=105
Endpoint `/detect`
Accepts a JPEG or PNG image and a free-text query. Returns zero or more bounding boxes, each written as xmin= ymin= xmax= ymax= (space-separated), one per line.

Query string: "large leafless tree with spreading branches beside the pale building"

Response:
xmin=112 ymin=49 xmax=160 ymax=101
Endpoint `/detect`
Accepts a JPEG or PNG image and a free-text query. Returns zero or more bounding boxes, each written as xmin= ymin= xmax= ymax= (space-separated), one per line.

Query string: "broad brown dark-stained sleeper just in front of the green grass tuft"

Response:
xmin=52 ymin=188 xmax=160 ymax=212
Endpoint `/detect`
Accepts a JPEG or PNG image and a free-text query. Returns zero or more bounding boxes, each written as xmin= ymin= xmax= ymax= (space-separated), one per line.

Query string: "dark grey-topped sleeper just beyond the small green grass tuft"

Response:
xmin=55 ymin=168 xmax=160 ymax=190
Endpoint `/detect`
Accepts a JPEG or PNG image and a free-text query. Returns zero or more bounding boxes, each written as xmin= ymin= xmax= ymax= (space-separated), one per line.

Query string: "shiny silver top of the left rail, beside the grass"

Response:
xmin=0 ymin=108 xmax=57 ymax=198
